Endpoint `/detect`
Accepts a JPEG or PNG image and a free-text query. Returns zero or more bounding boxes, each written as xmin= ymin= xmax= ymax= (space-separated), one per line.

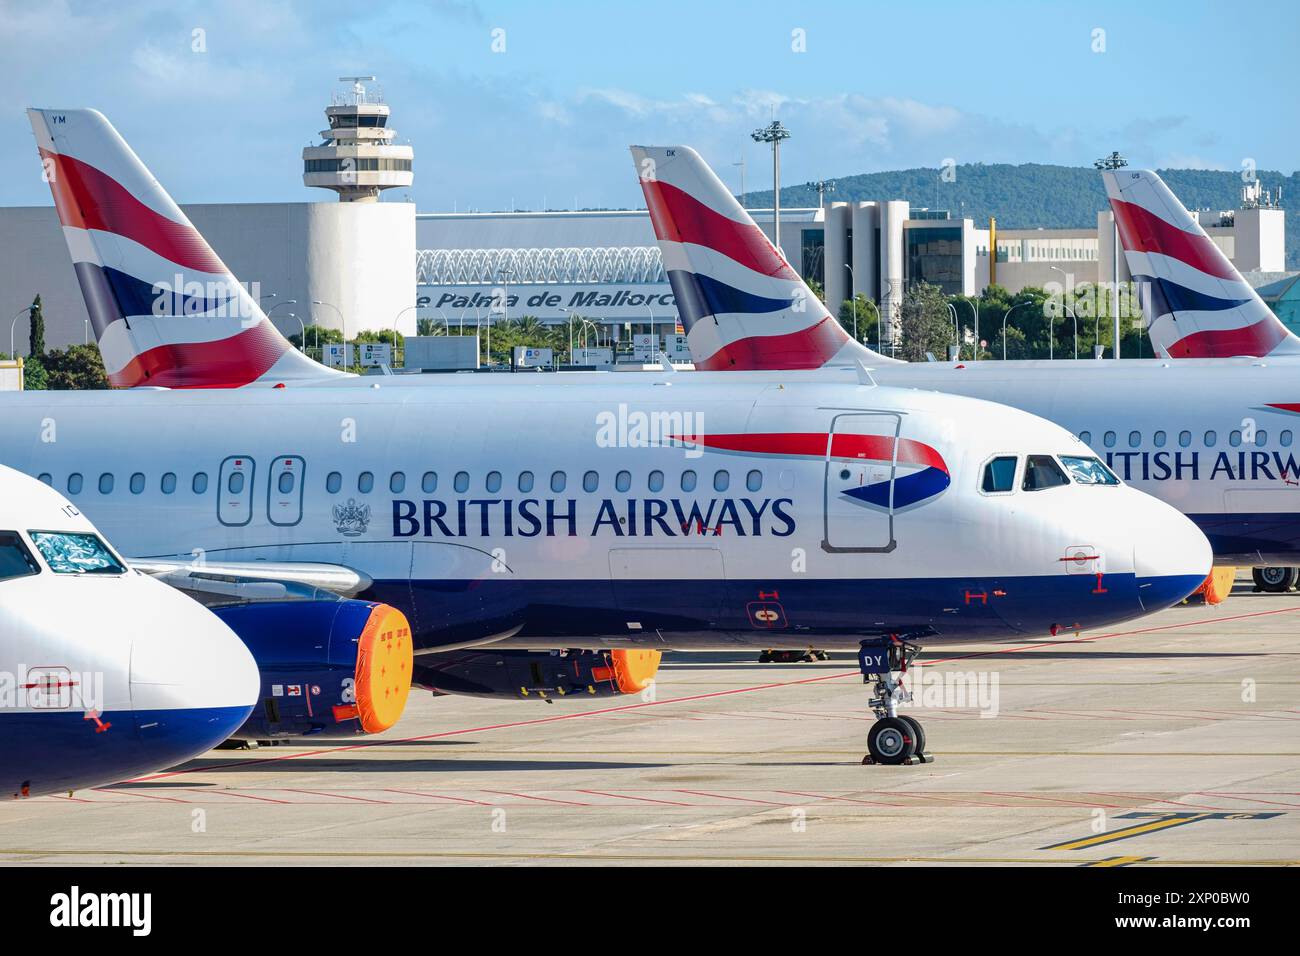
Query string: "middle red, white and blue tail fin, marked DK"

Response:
xmin=632 ymin=146 xmax=893 ymax=372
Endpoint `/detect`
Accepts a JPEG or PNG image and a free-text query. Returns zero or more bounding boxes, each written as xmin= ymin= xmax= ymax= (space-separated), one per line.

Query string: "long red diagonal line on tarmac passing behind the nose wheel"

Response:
xmin=133 ymin=607 xmax=1300 ymax=783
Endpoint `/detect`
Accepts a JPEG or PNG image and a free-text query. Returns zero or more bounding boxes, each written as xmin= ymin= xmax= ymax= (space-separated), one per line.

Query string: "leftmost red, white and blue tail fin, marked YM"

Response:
xmin=27 ymin=109 xmax=338 ymax=388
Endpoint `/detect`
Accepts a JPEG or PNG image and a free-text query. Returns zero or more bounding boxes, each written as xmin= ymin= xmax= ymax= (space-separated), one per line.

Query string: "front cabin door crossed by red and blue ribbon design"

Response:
xmin=822 ymin=412 xmax=902 ymax=553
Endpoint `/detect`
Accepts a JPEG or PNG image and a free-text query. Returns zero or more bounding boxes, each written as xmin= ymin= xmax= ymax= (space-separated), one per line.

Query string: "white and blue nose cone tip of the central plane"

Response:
xmin=1134 ymin=498 xmax=1214 ymax=611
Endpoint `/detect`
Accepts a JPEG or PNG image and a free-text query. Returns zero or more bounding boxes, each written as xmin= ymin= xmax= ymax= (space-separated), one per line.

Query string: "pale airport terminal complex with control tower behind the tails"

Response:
xmin=0 ymin=77 xmax=1287 ymax=351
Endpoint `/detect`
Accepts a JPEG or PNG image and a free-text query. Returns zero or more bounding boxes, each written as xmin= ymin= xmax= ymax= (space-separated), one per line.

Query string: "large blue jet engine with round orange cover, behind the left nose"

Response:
xmin=213 ymin=601 xmax=412 ymax=740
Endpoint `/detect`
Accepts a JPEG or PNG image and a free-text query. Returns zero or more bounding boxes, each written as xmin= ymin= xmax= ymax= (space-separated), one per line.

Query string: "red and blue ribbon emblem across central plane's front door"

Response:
xmin=675 ymin=432 xmax=952 ymax=511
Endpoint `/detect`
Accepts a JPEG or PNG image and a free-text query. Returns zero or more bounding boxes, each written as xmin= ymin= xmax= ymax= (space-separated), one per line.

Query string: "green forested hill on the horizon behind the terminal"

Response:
xmin=745 ymin=163 xmax=1300 ymax=269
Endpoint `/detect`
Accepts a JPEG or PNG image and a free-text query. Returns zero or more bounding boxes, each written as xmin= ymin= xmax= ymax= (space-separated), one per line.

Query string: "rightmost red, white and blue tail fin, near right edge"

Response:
xmin=1102 ymin=169 xmax=1300 ymax=359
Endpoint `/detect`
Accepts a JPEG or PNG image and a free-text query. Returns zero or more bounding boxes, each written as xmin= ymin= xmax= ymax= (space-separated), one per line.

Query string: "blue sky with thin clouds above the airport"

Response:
xmin=0 ymin=0 xmax=1300 ymax=211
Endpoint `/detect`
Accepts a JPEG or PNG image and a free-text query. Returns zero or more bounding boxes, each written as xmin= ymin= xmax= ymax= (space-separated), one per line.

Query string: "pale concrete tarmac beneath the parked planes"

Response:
xmin=0 ymin=576 xmax=1300 ymax=866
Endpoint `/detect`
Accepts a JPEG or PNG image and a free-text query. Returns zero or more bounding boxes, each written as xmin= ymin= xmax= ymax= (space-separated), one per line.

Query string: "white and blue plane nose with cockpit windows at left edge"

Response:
xmin=0 ymin=466 xmax=259 ymax=799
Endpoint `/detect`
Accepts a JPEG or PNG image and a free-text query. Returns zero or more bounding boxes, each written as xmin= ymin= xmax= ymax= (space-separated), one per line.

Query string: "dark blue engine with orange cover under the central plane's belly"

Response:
xmin=413 ymin=649 xmax=662 ymax=701
